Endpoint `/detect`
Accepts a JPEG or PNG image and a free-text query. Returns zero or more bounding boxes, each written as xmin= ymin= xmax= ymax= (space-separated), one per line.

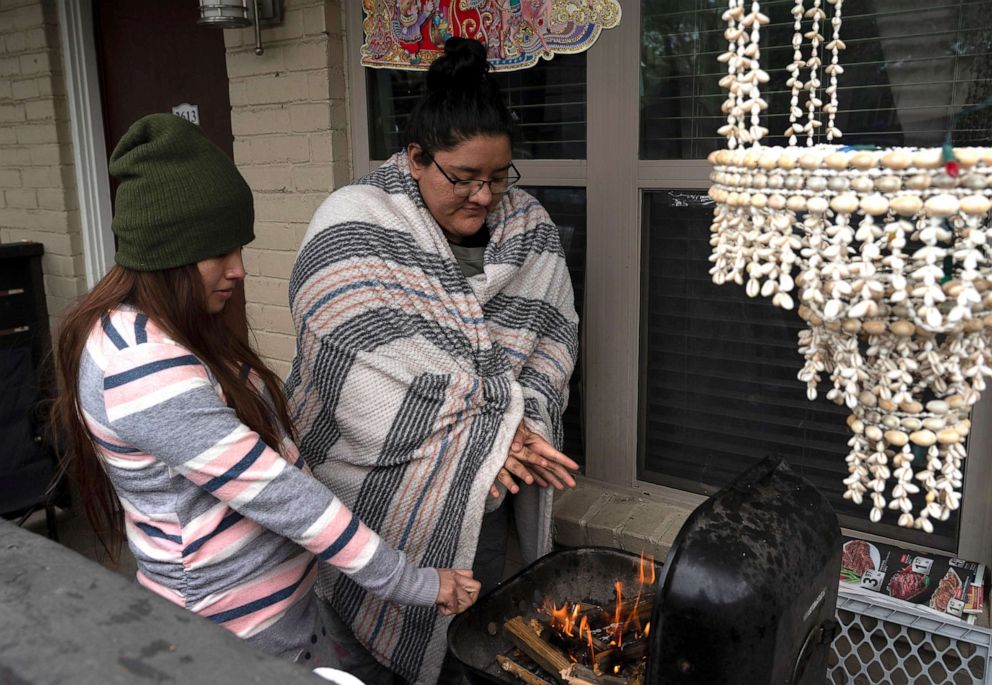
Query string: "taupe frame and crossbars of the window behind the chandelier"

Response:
xmin=343 ymin=1 xmax=992 ymax=564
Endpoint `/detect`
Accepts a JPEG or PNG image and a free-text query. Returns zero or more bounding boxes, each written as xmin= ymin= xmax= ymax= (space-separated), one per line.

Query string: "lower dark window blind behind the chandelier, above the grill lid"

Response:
xmin=638 ymin=191 xmax=958 ymax=551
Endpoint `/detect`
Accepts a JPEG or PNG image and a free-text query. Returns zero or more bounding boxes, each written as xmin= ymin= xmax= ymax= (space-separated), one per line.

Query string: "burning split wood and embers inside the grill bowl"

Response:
xmin=498 ymin=554 xmax=656 ymax=685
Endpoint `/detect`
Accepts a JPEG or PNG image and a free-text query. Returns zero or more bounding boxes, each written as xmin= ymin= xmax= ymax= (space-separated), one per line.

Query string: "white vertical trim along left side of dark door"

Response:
xmin=58 ymin=0 xmax=114 ymax=288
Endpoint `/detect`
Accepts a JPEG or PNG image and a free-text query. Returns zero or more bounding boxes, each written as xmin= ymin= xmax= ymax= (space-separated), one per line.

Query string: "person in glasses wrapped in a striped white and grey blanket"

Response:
xmin=287 ymin=38 xmax=578 ymax=683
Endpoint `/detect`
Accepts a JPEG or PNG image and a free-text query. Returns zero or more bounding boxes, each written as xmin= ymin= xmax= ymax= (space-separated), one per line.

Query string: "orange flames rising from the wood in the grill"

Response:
xmin=540 ymin=553 xmax=656 ymax=675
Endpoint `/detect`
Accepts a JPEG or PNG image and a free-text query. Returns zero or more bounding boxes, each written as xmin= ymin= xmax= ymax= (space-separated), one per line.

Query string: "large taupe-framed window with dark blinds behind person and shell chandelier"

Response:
xmin=348 ymin=0 xmax=992 ymax=562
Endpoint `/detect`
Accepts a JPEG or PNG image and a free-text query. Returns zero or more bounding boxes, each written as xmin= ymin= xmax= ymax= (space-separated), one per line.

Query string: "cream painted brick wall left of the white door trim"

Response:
xmin=0 ymin=0 xmax=86 ymax=323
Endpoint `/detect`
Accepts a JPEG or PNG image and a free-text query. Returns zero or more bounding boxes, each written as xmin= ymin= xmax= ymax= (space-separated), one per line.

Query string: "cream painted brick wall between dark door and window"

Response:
xmin=224 ymin=0 xmax=351 ymax=378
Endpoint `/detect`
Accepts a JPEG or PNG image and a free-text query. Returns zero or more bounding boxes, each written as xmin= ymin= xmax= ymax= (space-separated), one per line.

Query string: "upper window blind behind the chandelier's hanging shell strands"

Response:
xmin=640 ymin=0 xmax=992 ymax=159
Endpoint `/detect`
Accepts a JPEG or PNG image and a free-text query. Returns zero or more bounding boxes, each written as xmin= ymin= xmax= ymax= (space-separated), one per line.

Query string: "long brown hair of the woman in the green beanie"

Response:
xmin=52 ymin=264 xmax=294 ymax=560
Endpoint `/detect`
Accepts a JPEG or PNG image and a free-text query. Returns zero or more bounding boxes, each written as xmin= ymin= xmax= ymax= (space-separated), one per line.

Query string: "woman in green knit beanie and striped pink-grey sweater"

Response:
xmin=56 ymin=114 xmax=479 ymax=667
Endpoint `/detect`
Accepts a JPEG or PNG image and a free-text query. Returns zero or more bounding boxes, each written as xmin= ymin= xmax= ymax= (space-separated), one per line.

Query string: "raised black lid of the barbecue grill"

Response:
xmin=646 ymin=458 xmax=841 ymax=685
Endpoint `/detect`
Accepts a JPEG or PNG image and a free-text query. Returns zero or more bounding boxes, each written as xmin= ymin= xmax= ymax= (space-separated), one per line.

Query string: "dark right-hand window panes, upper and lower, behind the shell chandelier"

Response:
xmin=638 ymin=0 xmax=992 ymax=550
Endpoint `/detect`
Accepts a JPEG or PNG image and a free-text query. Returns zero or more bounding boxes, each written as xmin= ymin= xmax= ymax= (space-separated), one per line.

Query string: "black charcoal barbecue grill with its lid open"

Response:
xmin=448 ymin=459 xmax=841 ymax=685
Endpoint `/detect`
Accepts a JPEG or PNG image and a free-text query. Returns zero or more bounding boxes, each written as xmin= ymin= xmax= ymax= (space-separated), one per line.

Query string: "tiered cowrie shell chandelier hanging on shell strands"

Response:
xmin=709 ymin=0 xmax=992 ymax=533
